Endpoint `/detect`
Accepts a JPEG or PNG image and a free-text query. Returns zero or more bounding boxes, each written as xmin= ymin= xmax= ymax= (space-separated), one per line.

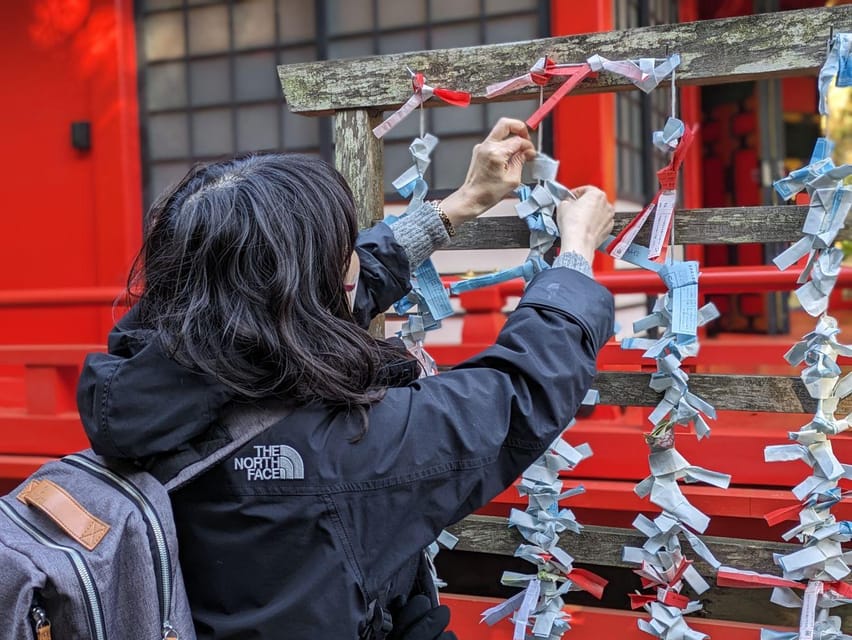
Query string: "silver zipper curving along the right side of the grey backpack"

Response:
xmin=62 ymin=454 xmax=178 ymax=640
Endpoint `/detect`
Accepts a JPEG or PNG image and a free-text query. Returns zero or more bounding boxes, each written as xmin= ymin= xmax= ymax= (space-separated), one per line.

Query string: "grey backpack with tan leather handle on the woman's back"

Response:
xmin=0 ymin=407 xmax=283 ymax=640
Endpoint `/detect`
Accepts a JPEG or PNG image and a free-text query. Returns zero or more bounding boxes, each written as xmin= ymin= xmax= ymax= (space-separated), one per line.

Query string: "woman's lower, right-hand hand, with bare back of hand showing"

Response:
xmin=556 ymin=186 xmax=615 ymax=264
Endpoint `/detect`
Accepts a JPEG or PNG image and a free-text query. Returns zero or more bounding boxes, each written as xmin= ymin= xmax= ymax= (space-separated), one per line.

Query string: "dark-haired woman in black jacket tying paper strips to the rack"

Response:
xmin=78 ymin=119 xmax=613 ymax=640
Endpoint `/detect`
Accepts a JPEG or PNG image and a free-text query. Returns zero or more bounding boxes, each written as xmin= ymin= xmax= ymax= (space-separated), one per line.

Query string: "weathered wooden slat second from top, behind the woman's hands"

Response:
xmin=446 ymin=205 xmax=852 ymax=250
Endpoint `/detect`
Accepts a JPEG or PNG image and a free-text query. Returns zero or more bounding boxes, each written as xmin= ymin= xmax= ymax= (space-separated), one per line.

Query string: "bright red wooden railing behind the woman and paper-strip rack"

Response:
xmin=0 ymin=266 xmax=852 ymax=524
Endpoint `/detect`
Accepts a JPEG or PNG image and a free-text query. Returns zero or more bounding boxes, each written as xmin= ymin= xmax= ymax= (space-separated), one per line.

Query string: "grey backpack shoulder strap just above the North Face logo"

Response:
xmin=145 ymin=400 xmax=292 ymax=493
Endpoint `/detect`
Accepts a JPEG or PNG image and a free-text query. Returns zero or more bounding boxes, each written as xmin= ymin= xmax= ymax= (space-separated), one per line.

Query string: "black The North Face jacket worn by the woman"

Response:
xmin=78 ymin=204 xmax=613 ymax=640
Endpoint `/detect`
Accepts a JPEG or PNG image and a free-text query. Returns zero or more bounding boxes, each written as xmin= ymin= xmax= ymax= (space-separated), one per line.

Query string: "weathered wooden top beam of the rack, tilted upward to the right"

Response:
xmin=278 ymin=6 xmax=852 ymax=115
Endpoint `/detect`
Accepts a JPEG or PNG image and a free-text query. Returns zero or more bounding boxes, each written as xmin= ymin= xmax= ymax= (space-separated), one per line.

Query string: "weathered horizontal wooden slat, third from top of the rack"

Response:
xmin=593 ymin=371 xmax=852 ymax=414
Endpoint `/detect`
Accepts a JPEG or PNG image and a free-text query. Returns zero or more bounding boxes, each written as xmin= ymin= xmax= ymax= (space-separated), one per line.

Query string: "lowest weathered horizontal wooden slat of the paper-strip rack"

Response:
xmin=448 ymin=516 xmax=800 ymax=577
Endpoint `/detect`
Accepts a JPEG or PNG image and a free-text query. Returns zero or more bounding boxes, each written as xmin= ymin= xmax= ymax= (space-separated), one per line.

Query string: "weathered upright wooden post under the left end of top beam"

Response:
xmin=334 ymin=109 xmax=385 ymax=338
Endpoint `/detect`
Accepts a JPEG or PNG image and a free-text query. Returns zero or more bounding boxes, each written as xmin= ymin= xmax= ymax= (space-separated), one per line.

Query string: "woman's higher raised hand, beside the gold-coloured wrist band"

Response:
xmin=441 ymin=118 xmax=536 ymax=226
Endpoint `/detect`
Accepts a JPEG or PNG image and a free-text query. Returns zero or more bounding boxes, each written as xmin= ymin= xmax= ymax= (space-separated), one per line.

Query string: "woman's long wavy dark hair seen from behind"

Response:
xmin=128 ymin=153 xmax=418 ymax=420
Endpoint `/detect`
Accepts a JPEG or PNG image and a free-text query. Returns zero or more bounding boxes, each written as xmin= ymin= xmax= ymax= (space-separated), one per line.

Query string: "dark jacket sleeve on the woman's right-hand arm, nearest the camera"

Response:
xmin=326 ymin=268 xmax=614 ymax=596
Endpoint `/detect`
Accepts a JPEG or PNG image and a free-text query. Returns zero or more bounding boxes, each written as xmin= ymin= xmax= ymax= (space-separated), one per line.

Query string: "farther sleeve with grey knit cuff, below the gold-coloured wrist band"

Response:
xmin=353 ymin=203 xmax=450 ymax=328
